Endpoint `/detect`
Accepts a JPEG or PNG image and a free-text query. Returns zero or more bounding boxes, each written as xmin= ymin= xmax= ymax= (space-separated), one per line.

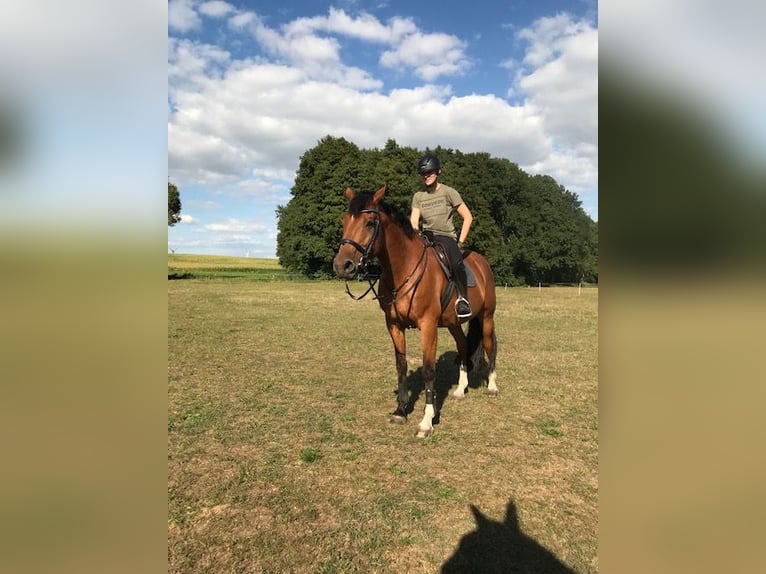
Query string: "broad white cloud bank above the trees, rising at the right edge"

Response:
xmin=168 ymin=24 xmax=597 ymax=191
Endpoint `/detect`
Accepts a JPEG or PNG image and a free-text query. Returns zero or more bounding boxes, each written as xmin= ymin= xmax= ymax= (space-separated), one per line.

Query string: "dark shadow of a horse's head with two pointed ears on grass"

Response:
xmin=441 ymin=500 xmax=576 ymax=574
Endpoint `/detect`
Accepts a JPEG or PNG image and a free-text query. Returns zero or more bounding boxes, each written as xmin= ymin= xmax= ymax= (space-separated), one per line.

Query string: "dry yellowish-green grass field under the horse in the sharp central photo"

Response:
xmin=168 ymin=255 xmax=598 ymax=574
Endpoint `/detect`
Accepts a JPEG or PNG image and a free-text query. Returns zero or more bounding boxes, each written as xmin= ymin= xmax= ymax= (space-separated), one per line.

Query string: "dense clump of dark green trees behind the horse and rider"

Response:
xmin=277 ymin=135 xmax=598 ymax=285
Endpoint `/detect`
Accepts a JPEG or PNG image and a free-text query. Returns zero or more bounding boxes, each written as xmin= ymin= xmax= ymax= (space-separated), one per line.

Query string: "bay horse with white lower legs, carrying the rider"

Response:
xmin=333 ymin=185 xmax=498 ymax=438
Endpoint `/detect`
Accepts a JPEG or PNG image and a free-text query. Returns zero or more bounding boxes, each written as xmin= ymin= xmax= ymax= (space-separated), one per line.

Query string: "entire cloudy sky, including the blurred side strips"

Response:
xmin=0 ymin=0 xmax=766 ymax=256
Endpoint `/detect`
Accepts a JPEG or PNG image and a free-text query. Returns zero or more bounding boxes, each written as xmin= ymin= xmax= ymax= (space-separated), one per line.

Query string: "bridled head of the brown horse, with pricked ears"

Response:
xmin=332 ymin=185 xmax=386 ymax=279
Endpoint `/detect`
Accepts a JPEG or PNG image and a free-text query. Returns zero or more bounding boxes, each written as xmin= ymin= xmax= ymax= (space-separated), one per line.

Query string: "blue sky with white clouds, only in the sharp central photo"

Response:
xmin=168 ymin=0 xmax=598 ymax=257
